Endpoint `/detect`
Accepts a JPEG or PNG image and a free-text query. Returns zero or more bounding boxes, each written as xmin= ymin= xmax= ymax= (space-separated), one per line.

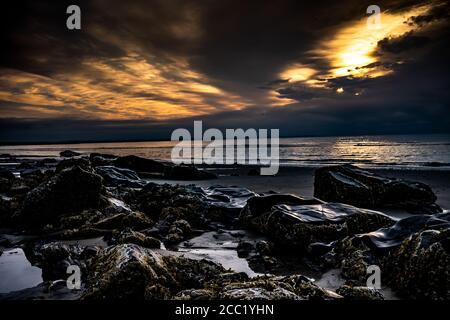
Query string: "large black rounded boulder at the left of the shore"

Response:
xmin=17 ymin=166 xmax=104 ymax=228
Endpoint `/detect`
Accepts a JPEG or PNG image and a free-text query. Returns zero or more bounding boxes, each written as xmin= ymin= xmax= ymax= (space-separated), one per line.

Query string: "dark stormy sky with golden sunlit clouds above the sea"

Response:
xmin=0 ymin=0 xmax=450 ymax=143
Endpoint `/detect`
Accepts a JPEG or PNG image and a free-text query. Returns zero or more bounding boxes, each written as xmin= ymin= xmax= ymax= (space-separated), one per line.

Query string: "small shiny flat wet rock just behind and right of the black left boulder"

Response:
xmin=95 ymin=166 xmax=146 ymax=188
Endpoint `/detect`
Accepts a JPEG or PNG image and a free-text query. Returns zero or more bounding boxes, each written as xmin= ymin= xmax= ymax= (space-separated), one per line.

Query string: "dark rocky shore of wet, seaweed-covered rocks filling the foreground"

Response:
xmin=0 ymin=150 xmax=450 ymax=300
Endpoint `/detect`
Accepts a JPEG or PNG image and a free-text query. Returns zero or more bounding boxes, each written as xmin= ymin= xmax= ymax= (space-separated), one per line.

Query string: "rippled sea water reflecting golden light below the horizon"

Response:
xmin=0 ymin=135 xmax=450 ymax=170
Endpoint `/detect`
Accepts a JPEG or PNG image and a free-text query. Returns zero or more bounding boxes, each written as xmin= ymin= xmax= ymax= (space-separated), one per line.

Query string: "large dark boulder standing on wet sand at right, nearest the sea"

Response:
xmin=314 ymin=165 xmax=442 ymax=213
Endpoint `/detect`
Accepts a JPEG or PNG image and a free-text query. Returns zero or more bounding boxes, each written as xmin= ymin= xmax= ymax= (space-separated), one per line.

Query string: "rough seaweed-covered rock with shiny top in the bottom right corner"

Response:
xmin=323 ymin=213 xmax=450 ymax=299
